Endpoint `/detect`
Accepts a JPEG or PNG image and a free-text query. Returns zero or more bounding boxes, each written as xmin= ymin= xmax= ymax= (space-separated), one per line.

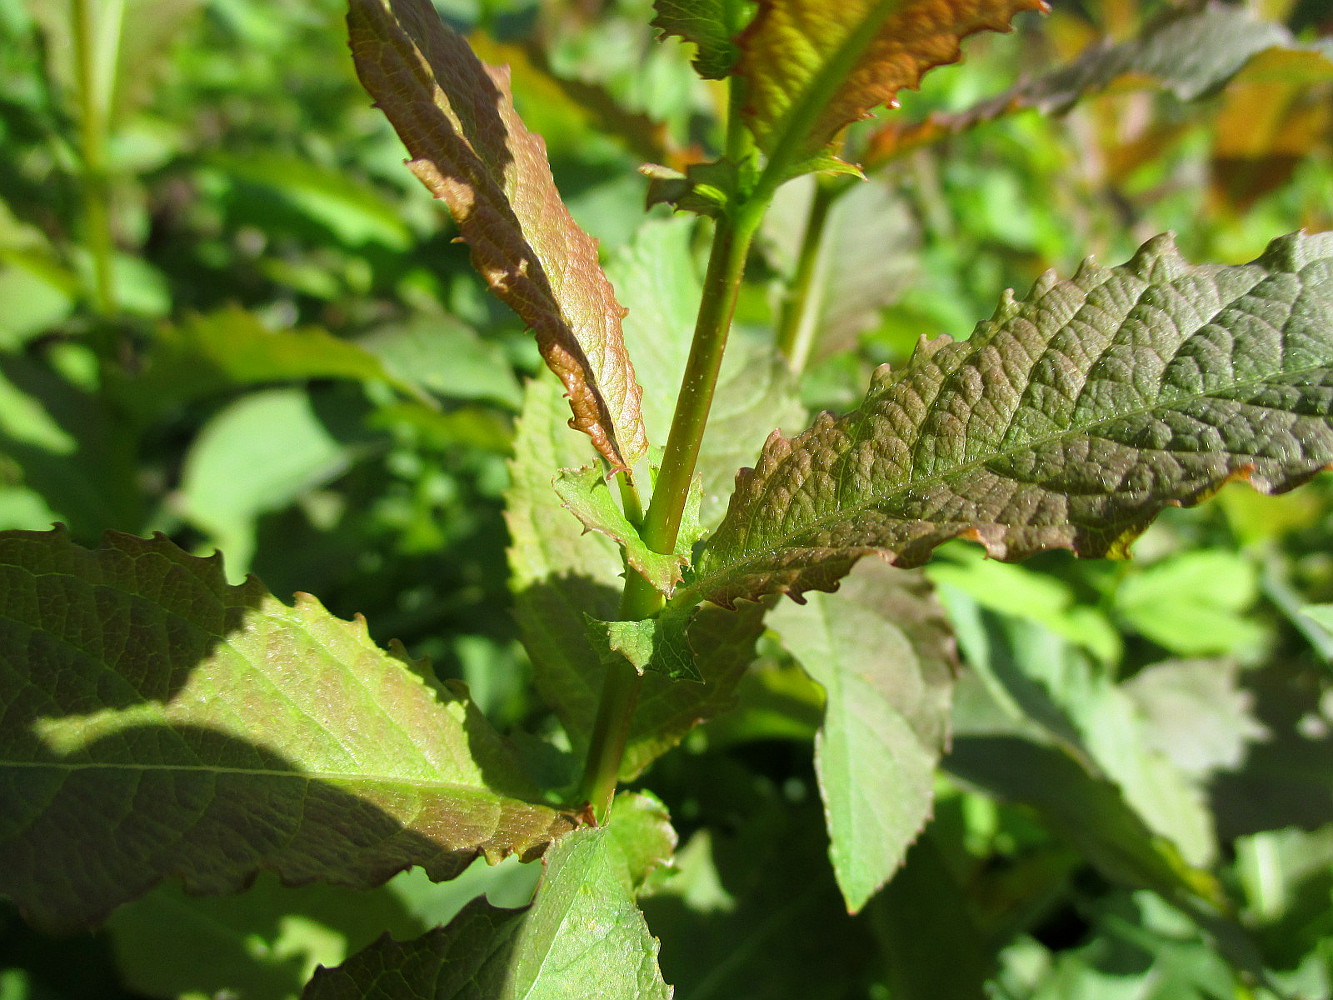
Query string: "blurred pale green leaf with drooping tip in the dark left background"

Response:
xmin=177 ymin=388 xmax=368 ymax=573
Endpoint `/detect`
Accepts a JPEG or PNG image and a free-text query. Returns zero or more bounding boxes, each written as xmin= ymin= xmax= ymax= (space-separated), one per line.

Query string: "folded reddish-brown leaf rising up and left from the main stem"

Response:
xmin=348 ymin=0 xmax=648 ymax=469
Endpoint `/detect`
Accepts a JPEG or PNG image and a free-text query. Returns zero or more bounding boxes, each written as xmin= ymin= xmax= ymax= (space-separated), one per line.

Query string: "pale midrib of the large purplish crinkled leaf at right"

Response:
xmin=673 ymin=346 xmax=1330 ymax=603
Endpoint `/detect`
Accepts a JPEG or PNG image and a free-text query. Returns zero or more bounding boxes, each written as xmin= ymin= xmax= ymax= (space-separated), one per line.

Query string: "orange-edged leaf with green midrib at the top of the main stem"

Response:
xmin=736 ymin=0 xmax=1045 ymax=167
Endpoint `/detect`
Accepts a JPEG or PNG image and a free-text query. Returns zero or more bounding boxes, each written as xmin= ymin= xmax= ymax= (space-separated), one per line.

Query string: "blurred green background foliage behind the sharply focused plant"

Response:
xmin=0 ymin=0 xmax=1333 ymax=1000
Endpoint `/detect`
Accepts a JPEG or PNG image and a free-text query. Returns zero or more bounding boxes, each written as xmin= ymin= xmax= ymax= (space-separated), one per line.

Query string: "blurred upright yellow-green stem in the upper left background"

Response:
xmin=69 ymin=0 xmax=120 ymax=325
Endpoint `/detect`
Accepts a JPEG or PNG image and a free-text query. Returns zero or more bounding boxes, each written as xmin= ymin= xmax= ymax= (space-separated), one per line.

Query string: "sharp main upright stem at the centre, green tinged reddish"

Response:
xmin=580 ymin=81 xmax=768 ymax=823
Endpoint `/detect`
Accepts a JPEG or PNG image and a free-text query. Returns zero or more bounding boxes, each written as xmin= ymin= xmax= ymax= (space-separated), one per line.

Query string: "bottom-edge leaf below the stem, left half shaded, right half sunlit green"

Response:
xmin=304 ymin=796 xmax=674 ymax=1000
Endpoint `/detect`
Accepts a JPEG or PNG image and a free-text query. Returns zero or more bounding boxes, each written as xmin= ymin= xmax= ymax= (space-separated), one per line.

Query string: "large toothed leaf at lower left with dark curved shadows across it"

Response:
xmin=0 ymin=531 xmax=573 ymax=929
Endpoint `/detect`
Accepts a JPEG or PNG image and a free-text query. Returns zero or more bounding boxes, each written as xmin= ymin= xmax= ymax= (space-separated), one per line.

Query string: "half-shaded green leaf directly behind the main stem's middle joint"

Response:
xmin=505 ymin=379 xmax=765 ymax=780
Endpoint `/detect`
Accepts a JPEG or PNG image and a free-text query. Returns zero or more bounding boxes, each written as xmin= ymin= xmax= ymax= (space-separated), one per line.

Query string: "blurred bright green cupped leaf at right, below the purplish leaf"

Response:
xmin=1116 ymin=549 xmax=1264 ymax=656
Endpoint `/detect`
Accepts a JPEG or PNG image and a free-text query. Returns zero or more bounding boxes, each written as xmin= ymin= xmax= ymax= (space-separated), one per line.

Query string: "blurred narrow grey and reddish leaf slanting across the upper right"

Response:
xmin=865 ymin=3 xmax=1326 ymax=168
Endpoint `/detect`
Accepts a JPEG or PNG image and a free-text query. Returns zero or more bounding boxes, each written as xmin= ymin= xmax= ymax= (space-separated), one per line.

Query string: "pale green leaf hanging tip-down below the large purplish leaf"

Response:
xmin=769 ymin=563 xmax=957 ymax=913
